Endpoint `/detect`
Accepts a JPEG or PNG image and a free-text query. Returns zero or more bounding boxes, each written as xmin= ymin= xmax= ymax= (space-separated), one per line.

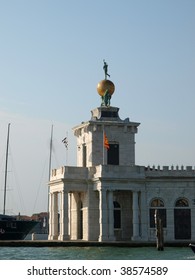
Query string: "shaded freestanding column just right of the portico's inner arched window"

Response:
xmin=132 ymin=191 xmax=140 ymax=240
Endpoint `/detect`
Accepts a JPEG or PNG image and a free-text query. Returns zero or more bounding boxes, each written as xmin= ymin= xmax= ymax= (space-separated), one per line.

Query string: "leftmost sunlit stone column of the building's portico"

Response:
xmin=49 ymin=192 xmax=58 ymax=240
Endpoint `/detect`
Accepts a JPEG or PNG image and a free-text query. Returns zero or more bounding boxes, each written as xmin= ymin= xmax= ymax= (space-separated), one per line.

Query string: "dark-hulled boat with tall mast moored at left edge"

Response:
xmin=0 ymin=123 xmax=38 ymax=240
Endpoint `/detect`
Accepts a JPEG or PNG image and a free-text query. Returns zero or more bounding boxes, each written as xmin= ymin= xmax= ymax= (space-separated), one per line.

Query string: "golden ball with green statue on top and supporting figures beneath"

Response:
xmin=97 ymin=60 xmax=115 ymax=107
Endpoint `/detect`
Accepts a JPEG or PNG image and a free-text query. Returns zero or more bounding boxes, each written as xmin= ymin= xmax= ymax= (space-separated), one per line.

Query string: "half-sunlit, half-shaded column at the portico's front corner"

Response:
xmin=99 ymin=189 xmax=108 ymax=241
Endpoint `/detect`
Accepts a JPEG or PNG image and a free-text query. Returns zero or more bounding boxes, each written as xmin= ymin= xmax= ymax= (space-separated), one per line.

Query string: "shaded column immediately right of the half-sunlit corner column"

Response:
xmin=108 ymin=191 xmax=115 ymax=241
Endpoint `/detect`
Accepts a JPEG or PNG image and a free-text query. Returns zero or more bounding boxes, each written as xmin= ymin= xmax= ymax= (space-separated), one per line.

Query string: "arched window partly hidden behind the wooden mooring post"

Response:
xmin=150 ymin=198 xmax=167 ymax=228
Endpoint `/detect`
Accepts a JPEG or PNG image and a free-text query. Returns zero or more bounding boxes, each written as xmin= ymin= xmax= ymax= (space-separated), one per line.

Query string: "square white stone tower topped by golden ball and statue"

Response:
xmin=73 ymin=62 xmax=139 ymax=167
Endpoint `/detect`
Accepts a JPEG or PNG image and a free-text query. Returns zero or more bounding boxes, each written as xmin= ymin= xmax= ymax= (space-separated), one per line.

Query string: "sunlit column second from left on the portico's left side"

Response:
xmin=58 ymin=191 xmax=69 ymax=240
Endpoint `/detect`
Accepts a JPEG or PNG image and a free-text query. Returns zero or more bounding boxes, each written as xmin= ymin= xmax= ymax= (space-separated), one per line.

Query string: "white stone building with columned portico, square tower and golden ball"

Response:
xmin=48 ymin=69 xmax=195 ymax=242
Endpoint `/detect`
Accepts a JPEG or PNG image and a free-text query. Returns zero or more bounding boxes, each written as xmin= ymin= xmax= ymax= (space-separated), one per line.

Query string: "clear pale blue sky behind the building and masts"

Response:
xmin=0 ymin=0 xmax=195 ymax=215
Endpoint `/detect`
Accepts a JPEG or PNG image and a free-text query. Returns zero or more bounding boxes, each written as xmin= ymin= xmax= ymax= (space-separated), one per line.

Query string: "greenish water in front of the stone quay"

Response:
xmin=0 ymin=247 xmax=195 ymax=260
